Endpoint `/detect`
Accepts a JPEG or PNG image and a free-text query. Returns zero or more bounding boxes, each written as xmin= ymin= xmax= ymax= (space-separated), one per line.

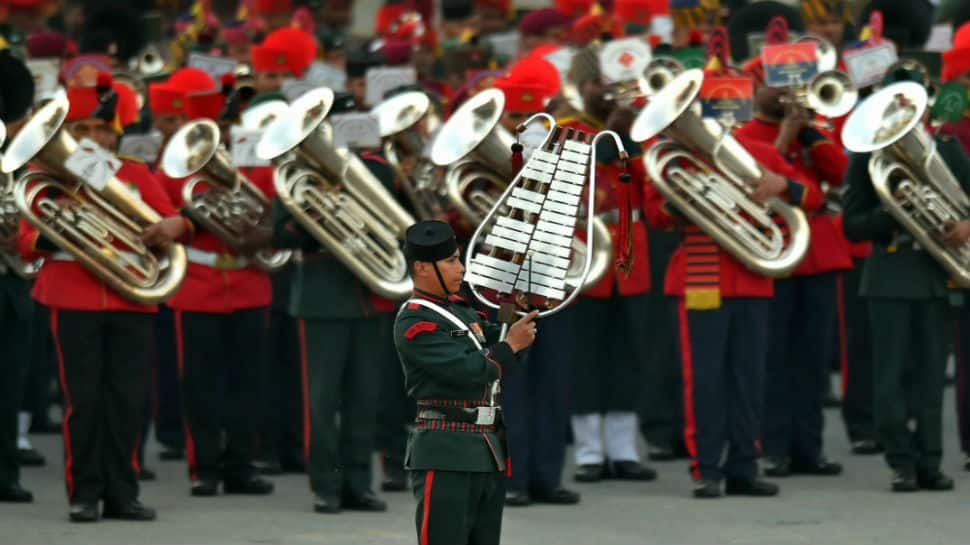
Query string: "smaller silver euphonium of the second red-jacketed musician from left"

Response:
xmin=160 ymin=119 xmax=291 ymax=271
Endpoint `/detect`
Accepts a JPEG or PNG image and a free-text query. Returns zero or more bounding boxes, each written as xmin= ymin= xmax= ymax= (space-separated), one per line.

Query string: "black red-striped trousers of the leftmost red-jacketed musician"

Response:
xmin=51 ymin=309 xmax=154 ymax=504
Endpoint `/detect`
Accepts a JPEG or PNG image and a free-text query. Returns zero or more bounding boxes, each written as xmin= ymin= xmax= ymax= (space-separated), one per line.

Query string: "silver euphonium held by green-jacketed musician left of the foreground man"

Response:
xmin=256 ymin=87 xmax=414 ymax=299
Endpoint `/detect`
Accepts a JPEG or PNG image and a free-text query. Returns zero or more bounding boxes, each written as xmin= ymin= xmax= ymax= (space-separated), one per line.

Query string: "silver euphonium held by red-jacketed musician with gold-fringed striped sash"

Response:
xmin=631 ymin=69 xmax=809 ymax=276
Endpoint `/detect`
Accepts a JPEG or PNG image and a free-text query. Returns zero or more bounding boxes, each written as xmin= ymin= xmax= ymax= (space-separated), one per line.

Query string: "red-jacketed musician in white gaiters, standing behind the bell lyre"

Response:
xmin=557 ymin=45 xmax=656 ymax=482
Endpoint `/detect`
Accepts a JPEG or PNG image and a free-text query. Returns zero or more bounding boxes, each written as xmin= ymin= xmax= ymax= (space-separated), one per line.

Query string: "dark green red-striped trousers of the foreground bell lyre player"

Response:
xmin=411 ymin=469 xmax=505 ymax=545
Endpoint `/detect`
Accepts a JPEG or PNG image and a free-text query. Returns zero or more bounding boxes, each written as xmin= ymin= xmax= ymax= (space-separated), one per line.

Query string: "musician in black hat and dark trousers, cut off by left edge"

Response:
xmin=0 ymin=49 xmax=34 ymax=502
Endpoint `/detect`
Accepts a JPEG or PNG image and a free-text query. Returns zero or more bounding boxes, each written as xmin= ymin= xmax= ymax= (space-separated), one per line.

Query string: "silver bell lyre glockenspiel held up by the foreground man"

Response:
xmin=465 ymin=113 xmax=626 ymax=316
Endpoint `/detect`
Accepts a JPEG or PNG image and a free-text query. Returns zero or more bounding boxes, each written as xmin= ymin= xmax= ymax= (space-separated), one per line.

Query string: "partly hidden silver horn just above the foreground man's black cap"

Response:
xmin=371 ymin=91 xmax=444 ymax=219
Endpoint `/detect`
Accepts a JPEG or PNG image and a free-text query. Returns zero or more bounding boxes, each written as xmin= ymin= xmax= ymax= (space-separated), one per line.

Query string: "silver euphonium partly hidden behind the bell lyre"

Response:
xmin=431 ymin=89 xmax=613 ymax=287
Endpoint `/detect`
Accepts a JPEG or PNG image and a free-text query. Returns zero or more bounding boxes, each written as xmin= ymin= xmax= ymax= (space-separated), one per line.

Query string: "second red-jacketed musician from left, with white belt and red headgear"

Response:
xmin=159 ymin=79 xmax=275 ymax=496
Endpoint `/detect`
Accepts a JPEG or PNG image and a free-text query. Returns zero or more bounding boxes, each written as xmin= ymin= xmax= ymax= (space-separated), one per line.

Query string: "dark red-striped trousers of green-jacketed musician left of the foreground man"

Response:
xmin=300 ymin=316 xmax=389 ymax=499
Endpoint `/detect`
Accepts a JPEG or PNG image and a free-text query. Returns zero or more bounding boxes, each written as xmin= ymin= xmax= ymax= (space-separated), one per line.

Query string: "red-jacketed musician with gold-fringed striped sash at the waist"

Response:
xmin=646 ymin=129 xmax=821 ymax=498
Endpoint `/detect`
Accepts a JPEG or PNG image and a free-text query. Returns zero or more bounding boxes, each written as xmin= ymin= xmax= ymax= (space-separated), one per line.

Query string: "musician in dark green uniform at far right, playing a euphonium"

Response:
xmin=844 ymin=99 xmax=970 ymax=492
